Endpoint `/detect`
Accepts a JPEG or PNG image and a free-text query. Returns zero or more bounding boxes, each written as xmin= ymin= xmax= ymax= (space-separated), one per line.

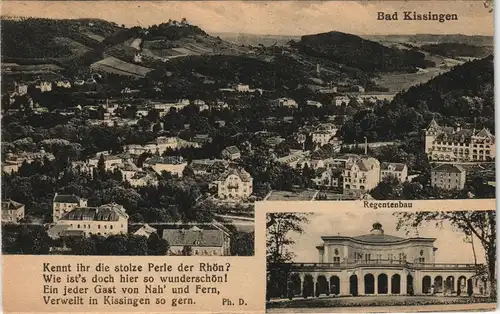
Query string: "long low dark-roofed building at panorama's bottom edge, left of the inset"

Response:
xmin=163 ymin=226 xmax=231 ymax=256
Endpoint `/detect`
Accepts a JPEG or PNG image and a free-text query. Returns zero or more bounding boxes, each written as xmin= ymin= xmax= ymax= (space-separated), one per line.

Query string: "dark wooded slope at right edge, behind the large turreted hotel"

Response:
xmin=341 ymin=56 xmax=495 ymax=143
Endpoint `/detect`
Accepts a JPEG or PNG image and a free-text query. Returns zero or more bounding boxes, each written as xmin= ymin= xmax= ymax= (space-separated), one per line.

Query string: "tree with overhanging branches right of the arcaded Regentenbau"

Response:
xmin=394 ymin=210 xmax=496 ymax=298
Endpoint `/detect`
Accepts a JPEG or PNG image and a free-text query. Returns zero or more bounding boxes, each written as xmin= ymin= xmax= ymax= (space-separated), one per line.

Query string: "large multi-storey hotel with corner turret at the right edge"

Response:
xmin=425 ymin=119 xmax=496 ymax=162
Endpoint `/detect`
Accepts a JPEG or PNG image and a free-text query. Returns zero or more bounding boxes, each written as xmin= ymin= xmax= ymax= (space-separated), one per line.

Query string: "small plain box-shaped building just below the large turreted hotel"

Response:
xmin=431 ymin=164 xmax=466 ymax=190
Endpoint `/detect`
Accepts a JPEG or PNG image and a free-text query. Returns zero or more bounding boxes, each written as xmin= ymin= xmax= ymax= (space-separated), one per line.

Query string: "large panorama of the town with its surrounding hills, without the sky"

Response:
xmin=1 ymin=17 xmax=496 ymax=255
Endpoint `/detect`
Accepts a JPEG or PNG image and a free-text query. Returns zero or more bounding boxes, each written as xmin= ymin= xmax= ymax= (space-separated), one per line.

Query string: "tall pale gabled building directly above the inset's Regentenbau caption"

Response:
xmin=342 ymin=157 xmax=380 ymax=192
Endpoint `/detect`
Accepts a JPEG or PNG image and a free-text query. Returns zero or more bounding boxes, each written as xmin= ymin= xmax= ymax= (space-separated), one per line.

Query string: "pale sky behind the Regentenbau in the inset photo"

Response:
xmin=289 ymin=211 xmax=485 ymax=264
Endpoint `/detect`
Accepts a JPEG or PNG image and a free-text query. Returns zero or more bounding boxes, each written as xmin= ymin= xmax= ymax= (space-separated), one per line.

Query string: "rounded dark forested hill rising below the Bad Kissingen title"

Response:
xmin=292 ymin=32 xmax=435 ymax=72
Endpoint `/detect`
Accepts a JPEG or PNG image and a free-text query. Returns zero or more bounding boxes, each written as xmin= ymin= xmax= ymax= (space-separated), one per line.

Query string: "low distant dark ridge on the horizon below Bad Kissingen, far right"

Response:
xmin=420 ymin=43 xmax=493 ymax=58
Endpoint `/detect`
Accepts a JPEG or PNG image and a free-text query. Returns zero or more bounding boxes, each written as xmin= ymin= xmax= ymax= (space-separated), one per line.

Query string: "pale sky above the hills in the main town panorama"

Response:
xmin=1 ymin=0 xmax=493 ymax=35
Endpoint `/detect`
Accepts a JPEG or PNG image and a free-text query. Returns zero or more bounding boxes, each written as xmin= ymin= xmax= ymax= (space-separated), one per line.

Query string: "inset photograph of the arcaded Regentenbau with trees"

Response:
xmin=266 ymin=210 xmax=497 ymax=313
